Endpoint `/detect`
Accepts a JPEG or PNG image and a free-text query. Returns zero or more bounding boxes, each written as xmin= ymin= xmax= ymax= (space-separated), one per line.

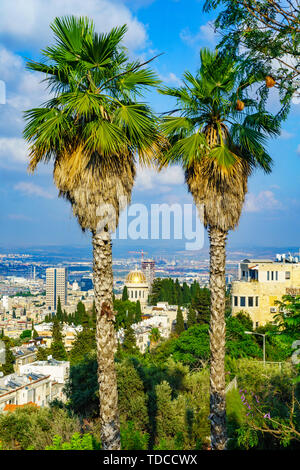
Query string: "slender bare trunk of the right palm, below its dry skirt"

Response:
xmin=209 ymin=227 xmax=227 ymax=450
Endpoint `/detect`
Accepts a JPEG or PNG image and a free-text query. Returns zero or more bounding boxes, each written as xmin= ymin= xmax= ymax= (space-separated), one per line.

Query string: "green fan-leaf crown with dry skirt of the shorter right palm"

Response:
xmin=159 ymin=49 xmax=280 ymax=230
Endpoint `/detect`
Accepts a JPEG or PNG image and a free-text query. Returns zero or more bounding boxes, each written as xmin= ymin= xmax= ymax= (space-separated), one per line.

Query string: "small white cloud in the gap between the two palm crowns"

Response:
xmin=136 ymin=166 xmax=184 ymax=193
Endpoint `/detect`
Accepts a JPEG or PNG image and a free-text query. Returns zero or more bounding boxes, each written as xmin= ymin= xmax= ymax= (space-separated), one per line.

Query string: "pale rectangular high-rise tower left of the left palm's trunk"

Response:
xmin=46 ymin=268 xmax=68 ymax=311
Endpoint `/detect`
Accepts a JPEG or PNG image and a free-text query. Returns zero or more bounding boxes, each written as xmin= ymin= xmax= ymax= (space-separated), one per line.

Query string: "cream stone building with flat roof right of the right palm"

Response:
xmin=232 ymin=259 xmax=300 ymax=328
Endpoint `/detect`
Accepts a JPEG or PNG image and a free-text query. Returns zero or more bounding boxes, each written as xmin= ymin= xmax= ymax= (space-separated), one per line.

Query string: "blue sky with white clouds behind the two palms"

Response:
xmin=0 ymin=0 xmax=300 ymax=247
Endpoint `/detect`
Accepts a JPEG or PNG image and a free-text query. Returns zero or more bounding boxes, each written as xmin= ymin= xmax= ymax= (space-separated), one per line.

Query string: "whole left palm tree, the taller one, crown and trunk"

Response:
xmin=24 ymin=16 xmax=160 ymax=449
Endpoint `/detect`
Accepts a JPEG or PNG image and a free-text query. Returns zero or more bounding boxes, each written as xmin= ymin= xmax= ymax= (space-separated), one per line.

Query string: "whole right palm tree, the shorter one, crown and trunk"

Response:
xmin=160 ymin=49 xmax=279 ymax=449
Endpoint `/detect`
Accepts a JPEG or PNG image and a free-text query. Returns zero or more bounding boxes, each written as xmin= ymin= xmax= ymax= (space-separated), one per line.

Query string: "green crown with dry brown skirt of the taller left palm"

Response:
xmin=24 ymin=16 xmax=161 ymax=231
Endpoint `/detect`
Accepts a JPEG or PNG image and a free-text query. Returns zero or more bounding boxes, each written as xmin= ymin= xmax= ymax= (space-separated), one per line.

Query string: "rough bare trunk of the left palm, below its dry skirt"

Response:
xmin=93 ymin=232 xmax=121 ymax=450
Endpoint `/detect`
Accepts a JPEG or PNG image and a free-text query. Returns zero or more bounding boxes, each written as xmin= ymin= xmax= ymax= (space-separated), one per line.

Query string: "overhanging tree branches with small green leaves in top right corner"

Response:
xmin=204 ymin=0 xmax=300 ymax=107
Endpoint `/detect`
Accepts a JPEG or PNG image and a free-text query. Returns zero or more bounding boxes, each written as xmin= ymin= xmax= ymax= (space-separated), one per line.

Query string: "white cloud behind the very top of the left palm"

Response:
xmin=0 ymin=0 xmax=147 ymax=50
